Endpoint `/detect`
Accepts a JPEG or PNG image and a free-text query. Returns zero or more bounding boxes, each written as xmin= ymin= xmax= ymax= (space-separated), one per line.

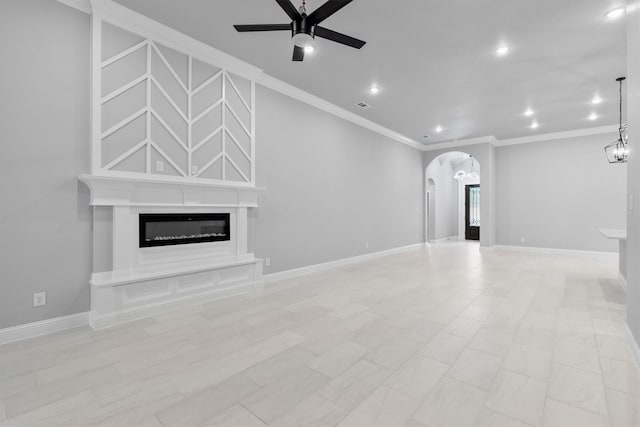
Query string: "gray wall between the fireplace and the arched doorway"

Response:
xmin=253 ymin=87 xmax=424 ymax=273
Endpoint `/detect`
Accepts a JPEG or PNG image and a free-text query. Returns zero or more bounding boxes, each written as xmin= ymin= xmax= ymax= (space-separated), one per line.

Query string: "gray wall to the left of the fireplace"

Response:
xmin=0 ymin=0 xmax=92 ymax=328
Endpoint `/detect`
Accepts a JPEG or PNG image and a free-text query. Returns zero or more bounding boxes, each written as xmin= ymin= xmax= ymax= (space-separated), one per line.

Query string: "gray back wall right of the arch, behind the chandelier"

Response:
xmin=496 ymin=134 xmax=626 ymax=252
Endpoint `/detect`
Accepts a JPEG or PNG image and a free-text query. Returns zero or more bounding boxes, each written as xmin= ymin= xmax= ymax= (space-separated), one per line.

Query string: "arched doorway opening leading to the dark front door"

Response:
xmin=425 ymin=151 xmax=481 ymax=242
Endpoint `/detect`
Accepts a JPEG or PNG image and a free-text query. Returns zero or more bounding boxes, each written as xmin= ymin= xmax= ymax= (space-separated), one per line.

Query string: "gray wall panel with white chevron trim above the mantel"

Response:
xmin=92 ymin=22 xmax=255 ymax=184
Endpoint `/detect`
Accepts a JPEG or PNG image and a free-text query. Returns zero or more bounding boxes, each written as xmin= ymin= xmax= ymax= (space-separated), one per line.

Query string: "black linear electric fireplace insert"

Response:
xmin=139 ymin=213 xmax=231 ymax=248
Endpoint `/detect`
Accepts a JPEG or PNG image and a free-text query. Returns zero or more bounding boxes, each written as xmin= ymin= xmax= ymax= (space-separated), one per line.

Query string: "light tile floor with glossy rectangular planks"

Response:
xmin=0 ymin=242 xmax=640 ymax=427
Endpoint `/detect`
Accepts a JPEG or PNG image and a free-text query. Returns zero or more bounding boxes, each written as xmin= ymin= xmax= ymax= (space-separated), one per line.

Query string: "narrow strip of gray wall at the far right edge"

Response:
xmin=625 ymin=0 xmax=640 ymax=354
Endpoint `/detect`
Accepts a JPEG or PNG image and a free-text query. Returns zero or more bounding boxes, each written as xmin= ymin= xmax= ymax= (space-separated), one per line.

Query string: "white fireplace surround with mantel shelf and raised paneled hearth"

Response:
xmin=78 ymin=175 xmax=264 ymax=329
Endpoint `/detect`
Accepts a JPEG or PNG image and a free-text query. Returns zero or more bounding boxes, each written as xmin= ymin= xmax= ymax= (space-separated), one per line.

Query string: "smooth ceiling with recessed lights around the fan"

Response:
xmin=117 ymin=0 xmax=626 ymax=143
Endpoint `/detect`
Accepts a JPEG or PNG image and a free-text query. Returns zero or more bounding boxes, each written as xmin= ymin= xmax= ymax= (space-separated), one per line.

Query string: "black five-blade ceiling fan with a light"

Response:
xmin=234 ymin=0 xmax=366 ymax=61
